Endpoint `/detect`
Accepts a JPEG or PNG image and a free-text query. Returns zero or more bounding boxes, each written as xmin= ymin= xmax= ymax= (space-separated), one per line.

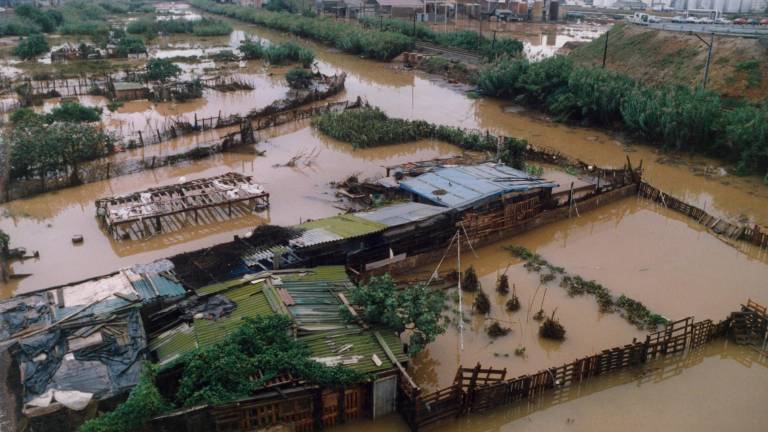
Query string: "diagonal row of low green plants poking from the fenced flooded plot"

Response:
xmin=507 ymin=246 xmax=667 ymax=330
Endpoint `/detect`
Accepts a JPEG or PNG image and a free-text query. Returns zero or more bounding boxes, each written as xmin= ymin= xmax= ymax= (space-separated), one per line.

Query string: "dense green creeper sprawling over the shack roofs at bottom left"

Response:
xmin=80 ymin=315 xmax=366 ymax=432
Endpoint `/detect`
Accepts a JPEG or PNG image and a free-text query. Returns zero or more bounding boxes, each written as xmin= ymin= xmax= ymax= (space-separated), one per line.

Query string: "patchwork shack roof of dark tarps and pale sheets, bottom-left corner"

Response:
xmin=0 ymin=261 xmax=185 ymax=430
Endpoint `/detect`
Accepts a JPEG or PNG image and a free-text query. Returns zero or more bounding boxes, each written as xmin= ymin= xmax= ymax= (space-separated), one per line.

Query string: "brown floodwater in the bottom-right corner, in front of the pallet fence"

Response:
xmin=334 ymin=341 xmax=768 ymax=432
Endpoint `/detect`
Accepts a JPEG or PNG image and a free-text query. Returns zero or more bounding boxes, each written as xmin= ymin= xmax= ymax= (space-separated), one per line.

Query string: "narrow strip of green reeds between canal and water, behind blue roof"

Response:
xmin=312 ymin=107 xmax=527 ymax=168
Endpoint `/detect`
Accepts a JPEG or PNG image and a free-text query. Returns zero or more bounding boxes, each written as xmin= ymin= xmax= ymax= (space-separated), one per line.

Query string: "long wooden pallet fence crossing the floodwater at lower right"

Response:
xmin=398 ymin=300 xmax=768 ymax=431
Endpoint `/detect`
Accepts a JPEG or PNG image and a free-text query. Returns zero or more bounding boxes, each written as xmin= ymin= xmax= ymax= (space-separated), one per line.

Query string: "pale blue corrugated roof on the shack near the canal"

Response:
xmin=400 ymin=163 xmax=557 ymax=210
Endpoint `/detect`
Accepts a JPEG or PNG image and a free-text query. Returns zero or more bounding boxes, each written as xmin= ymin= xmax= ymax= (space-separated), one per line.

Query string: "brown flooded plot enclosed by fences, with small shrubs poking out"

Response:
xmin=414 ymin=198 xmax=768 ymax=389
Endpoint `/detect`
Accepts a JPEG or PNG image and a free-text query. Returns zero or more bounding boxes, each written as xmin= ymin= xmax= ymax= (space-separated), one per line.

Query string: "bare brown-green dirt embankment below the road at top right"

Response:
xmin=570 ymin=23 xmax=768 ymax=100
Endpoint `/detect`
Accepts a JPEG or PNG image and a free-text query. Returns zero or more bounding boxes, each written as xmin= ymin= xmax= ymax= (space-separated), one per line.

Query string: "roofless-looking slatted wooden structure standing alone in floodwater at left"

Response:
xmin=96 ymin=172 xmax=269 ymax=240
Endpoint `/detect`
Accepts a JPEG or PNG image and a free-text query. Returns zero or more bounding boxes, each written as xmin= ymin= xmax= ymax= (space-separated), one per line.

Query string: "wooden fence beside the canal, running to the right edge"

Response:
xmin=638 ymin=182 xmax=768 ymax=249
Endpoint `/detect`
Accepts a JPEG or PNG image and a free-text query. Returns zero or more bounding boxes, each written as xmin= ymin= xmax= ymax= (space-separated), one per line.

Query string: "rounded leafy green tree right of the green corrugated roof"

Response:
xmin=342 ymin=274 xmax=448 ymax=355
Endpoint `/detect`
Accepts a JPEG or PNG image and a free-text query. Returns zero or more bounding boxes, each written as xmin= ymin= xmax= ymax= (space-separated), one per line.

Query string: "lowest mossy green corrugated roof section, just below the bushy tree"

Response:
xmin=299 ymin=329 xmax=408 ymax=373
